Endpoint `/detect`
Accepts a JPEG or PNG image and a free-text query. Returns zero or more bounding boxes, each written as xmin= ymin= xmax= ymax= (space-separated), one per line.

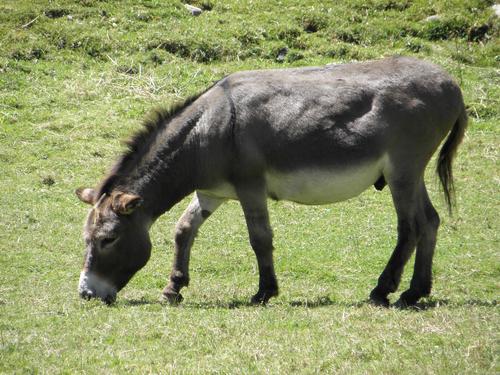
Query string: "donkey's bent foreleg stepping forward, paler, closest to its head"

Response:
xmin=163 ymin=192 xmax=224 ymax=303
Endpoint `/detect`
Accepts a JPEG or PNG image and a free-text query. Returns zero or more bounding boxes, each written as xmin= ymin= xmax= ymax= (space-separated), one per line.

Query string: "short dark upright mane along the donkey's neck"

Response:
xmin=97 ymin=83 xmax=216 ymax=197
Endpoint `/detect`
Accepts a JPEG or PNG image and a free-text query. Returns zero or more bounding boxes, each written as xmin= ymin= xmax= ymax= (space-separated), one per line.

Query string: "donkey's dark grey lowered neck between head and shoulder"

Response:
xmin=103 ymin=108 xmax=202 ymax=220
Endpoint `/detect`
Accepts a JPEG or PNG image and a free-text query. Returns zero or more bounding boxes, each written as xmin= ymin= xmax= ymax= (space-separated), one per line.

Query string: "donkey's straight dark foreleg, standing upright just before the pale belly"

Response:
xmin=238 ymin=185 xmax=278 ymax=304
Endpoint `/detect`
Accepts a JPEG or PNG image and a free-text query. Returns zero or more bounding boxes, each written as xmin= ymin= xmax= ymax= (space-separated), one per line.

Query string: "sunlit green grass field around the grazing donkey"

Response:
xmin=0 ymin=0 xmax=500 ymax=374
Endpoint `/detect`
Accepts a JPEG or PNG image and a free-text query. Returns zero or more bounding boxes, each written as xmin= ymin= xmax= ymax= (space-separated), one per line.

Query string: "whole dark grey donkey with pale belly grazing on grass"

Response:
xmin=76 ymin=57 xmax=467 ymax=306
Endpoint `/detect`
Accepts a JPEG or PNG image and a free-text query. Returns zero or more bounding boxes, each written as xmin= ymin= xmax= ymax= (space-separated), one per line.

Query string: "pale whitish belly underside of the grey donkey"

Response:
xmin=266 ymin=160 xmax=382 ymax=204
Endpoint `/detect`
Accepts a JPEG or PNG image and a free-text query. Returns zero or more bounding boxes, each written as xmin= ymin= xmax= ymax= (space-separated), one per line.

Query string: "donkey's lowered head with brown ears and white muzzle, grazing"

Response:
xmin=76 ymin=189 xmax=151 ymax=303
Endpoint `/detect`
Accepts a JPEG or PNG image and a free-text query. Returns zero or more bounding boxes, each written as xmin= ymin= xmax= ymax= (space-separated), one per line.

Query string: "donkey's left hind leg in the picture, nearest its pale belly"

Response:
xmin=370 ymin=177 xmax=420 ymax=306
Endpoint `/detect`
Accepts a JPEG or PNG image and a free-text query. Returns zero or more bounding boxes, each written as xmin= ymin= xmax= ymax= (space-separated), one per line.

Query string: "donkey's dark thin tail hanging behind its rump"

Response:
xmin=436 ymin=107 xmax=467 ymax=214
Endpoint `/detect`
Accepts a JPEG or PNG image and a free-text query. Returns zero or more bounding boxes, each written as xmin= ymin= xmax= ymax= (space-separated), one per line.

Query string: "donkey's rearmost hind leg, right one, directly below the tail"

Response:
xmin=396 ymin=183 xmax=439 ymax=307
